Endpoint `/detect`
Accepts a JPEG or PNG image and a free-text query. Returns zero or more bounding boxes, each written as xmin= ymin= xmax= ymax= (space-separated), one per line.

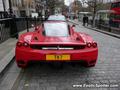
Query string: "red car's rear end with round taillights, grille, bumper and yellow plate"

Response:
xmin=16 ymin=42 xmax=98 ymax=66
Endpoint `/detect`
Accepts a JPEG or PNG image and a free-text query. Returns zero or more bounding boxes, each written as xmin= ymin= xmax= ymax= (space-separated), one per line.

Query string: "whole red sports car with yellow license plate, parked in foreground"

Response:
xmin=15 ymin=21 xmax=98 ymax=67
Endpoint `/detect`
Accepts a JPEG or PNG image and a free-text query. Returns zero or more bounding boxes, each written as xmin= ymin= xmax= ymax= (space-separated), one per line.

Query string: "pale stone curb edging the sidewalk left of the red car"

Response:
xmin=0 ymin=48 xmax=15 ymax=76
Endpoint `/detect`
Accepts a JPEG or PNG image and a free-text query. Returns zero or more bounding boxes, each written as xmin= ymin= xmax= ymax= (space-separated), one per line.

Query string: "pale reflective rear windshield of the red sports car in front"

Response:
xmin=44 ymin=22 xmax=69 ymax=37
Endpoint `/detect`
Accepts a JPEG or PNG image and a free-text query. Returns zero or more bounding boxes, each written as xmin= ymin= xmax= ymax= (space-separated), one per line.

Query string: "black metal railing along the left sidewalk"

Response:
xmin=0 ymin=17 xmax=42 ymax=43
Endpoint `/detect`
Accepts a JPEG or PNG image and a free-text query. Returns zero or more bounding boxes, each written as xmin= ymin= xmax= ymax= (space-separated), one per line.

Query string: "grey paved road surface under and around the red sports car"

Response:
xmin=0 ymin=22 xmax=120 ymax=90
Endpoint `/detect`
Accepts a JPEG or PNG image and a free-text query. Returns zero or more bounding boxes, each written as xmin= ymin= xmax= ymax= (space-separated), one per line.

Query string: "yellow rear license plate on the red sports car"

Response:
xmin=46 ymin=55 xmax=70 ymax=61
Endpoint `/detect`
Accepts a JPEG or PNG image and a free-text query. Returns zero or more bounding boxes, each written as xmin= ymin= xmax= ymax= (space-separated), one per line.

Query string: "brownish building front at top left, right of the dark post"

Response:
xmin=12 ymin=0 xmax=35 ymax=17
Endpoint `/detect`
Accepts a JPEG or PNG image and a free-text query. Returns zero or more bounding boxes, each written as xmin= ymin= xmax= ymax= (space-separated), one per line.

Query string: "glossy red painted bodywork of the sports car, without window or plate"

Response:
xmin=15 ymin=22 xmax=98 ymax=67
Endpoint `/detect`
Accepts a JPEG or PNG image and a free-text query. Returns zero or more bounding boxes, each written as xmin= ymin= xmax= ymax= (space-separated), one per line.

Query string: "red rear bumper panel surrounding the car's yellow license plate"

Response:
xmin=15 ymin=48 xmax=98 ymax=63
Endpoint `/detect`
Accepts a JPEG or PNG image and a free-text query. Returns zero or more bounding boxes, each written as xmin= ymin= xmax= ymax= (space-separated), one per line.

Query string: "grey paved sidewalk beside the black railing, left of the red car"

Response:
xmin=0 ymin=28 xmax=33 ymax=74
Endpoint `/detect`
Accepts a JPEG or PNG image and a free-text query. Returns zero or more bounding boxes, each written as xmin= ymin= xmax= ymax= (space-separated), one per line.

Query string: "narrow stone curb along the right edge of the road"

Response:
xmin=68 ymin=20 xmax=120 ymax=39
